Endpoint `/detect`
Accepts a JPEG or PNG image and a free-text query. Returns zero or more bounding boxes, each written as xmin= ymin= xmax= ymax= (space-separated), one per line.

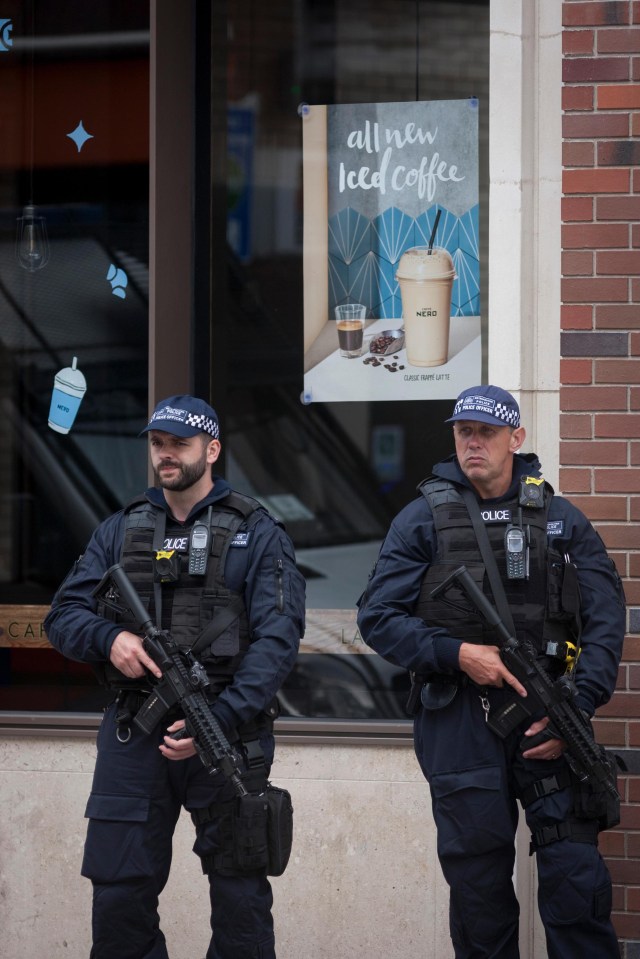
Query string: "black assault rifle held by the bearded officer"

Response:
xmin=94 ymin=564 xmax=248 ymax=796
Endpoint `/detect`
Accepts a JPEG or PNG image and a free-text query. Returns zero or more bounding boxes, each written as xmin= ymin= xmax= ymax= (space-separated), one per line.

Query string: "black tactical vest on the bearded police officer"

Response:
xmin=98 ymin=491 xmax=260 ymax=694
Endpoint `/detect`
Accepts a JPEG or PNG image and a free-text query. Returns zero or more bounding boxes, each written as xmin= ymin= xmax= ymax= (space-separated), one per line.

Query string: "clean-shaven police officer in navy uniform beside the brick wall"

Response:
xmin=358 ymin=386 xmax=625 ymax=959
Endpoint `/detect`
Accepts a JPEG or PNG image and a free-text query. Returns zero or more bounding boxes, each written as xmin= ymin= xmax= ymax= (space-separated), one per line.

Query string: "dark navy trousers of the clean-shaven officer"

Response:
xmin=414 ymin=685 xmax=620 ymax=959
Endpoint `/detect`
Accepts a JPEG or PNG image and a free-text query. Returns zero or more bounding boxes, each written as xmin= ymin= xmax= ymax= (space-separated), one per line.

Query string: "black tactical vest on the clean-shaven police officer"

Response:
xmin=415 ymin=477 xmax=580 ymax=663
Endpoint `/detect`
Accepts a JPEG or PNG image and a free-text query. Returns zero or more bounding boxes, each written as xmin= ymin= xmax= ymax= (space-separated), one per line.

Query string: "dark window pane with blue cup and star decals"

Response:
xmin=0 ymin=0 xmax=149 ymax=709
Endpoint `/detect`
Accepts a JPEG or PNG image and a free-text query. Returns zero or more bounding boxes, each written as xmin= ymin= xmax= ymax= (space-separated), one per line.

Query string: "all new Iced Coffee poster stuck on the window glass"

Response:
xmin=300 ymin=99 xmax=482 ymax=403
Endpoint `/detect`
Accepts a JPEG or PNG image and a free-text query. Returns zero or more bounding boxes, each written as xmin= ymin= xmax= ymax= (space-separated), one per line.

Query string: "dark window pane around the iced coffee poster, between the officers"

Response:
xmin=212 ymin=0 xmax=489 ymax=718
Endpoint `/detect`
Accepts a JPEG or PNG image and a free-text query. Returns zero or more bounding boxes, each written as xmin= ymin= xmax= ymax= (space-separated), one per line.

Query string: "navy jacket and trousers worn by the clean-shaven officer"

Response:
xmin=358 ymin=455 xmax=625 ymax=959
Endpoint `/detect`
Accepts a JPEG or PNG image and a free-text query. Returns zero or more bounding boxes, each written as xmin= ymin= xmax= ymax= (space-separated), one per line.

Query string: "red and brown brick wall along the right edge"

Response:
xmin=560 ymin=0 xmax=640 ymax=959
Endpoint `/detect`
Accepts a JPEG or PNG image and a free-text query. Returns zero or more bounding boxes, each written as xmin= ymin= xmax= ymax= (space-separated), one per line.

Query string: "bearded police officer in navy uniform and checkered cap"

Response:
xmin=45 ymin=395 xmax=305 ymax=959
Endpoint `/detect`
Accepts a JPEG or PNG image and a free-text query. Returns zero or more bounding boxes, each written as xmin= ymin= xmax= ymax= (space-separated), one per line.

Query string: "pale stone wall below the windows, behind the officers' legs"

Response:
xmin=0 ymin=737 xmax=453 ymax=959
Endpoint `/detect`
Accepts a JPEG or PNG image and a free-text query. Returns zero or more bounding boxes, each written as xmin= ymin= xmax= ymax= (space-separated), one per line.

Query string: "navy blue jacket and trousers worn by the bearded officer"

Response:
xmin=45 ymin=477 xmax=305 ymax=959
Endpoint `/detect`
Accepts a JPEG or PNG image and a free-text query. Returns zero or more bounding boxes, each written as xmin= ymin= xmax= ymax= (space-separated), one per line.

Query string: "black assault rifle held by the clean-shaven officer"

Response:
xmin=431 ymin=566 xmax=619 ymax=800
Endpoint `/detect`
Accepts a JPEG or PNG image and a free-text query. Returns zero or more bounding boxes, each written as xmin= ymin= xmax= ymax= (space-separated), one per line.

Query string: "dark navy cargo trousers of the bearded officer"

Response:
xmin=82 ymin=707 xmax=275 ymax=959
